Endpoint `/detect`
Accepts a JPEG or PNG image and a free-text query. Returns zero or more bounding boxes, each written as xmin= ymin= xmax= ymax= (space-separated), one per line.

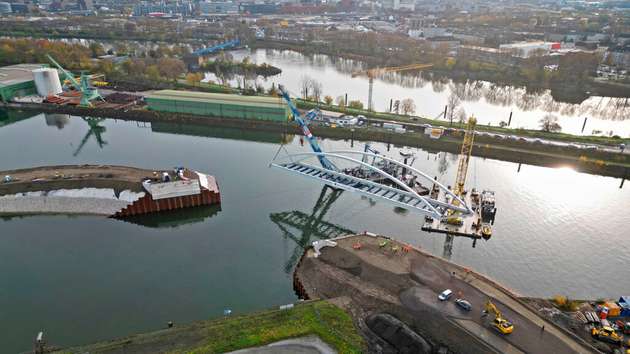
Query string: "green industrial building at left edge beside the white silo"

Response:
xmin=0 ymin=64 xmax=45 ymax=102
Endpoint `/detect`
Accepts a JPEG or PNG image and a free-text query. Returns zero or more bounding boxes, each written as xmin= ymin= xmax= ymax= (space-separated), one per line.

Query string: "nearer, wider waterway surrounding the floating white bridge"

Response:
xmin=0 ymin=114 xmax=630 ymax=352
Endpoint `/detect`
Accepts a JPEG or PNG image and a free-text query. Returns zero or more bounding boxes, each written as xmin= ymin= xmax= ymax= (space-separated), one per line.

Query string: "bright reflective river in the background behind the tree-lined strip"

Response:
xmin=207 ymin=49 xmax=630 ymax=137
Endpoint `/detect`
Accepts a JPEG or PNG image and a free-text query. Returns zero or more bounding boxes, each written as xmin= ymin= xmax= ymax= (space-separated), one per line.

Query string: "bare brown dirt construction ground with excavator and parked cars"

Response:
xmin=295 ymin=235 xmax=595 ymax=353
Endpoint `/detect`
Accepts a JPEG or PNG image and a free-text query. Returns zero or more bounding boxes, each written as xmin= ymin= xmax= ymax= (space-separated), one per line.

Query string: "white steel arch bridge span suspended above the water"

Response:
xmin=271 ymin=150 xmax=473 ymax=219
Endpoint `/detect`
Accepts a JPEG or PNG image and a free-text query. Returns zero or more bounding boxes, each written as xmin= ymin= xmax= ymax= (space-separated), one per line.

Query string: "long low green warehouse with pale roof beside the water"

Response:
xmin=145 ymin=90 xmax=289 ymax=121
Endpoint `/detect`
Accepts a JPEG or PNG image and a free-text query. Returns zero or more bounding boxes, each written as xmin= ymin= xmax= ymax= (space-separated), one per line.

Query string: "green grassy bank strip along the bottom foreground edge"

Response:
xmin=59 ymin=301 xmax=366 ymax=354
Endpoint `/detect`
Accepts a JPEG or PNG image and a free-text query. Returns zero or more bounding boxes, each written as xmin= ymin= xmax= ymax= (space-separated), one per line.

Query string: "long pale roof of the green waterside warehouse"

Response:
xmin=146 ymin=90 xmax=286 ymax=108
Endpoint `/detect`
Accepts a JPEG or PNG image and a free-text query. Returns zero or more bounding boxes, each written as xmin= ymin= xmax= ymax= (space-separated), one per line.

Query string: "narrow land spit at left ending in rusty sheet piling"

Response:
xmin=0 ymin=165 xmax=221 ymax=218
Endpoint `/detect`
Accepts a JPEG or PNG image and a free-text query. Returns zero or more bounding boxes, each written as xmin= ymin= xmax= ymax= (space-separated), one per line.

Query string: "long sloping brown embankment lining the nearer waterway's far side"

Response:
xmin=6 ymin=104 xmax=630 ymax=178
